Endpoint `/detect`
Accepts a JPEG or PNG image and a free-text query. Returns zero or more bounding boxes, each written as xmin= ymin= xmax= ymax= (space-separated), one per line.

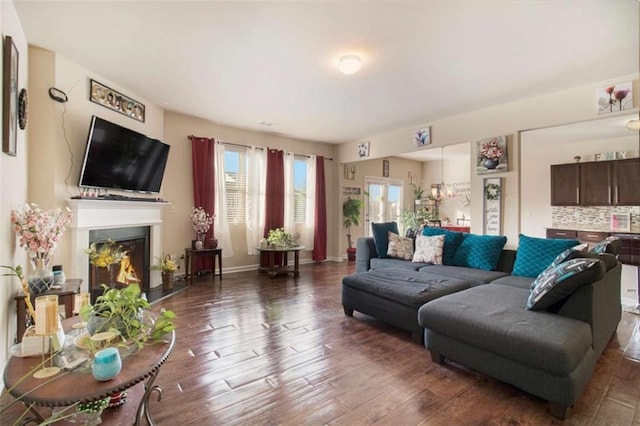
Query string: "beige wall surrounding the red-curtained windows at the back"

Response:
xmin=163 ymin=112 xmax=339 ymax=272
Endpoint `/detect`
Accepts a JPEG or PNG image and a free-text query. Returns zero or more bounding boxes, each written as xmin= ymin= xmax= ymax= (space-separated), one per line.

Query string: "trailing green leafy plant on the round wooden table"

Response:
xmin=80 ymin=284 xmax=176 ymax=349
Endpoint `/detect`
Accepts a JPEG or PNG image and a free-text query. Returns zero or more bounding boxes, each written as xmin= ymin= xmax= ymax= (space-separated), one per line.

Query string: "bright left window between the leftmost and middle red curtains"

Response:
xmin=224 ymin=148 xmax=247 ymax=223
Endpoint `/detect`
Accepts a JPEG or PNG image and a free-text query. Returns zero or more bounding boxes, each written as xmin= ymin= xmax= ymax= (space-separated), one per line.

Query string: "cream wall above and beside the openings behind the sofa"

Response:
xmin=338 ymin=73 xmax=639 ymax=248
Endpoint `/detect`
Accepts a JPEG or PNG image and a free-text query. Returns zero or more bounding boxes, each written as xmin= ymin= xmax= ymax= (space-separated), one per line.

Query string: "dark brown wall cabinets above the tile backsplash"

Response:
xmin=551 ymin=158 xmax=640 ymax=206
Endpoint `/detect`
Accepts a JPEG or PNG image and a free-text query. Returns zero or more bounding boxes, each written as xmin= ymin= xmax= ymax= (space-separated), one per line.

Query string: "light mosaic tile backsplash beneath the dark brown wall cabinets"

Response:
xmin=551 ymin=206 xmax=640 ymax=233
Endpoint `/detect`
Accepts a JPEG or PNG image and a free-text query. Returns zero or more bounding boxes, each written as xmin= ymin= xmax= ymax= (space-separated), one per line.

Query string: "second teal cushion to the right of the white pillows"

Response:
xmin=453 ymin=234 xmax=508 ymax=271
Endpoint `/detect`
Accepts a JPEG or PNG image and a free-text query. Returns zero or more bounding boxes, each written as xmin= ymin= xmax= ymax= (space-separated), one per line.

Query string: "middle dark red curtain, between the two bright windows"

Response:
xmin=260 ymin=149 xmax=284 ymax=267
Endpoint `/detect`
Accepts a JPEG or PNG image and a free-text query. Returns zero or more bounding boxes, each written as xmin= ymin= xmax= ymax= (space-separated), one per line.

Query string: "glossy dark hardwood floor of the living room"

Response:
xmin=0 ymin=262 xmax=640 ymax=426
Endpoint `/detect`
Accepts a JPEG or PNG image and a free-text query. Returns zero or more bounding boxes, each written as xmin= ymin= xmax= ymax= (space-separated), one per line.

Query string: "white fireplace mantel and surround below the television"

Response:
xmin=65 ymin=199 xmax=168 ymax=292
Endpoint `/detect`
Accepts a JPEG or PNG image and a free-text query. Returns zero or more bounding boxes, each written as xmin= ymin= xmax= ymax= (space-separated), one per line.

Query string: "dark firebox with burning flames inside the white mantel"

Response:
xmin=89 ymin=226 xmax=151 ymax=299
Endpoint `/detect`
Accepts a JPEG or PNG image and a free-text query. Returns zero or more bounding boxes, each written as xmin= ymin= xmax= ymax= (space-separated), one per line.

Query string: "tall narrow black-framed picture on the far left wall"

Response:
xmin=2 ymin=36 xmax=19 ymax=157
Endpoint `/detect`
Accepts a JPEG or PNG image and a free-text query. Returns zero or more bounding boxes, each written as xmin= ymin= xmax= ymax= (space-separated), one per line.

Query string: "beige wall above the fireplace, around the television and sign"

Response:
xmin=28 ymin=46 xmax=164 ymax=285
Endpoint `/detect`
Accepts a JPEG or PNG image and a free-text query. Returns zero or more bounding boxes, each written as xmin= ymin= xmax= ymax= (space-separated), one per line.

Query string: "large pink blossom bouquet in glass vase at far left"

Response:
xmin=11 ymin=204 xmax=71 ymax=266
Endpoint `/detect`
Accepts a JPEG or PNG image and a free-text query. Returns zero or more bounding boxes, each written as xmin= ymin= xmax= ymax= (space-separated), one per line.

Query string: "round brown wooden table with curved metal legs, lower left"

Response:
xmin=4 ymin=316 xmax=175 ymax=425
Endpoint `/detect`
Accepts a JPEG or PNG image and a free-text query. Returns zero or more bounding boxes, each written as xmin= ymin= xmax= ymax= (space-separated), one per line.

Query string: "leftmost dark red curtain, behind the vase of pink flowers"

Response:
xmin=189 ymin=136 xmax=216 ymax=273
